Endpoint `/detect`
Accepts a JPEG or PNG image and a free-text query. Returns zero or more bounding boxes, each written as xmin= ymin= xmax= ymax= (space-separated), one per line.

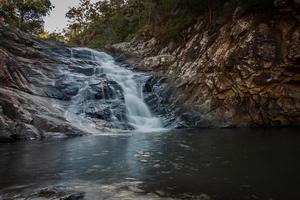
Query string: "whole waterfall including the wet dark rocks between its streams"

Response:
xmin=52 ymin=48 xmax=163 ymax=133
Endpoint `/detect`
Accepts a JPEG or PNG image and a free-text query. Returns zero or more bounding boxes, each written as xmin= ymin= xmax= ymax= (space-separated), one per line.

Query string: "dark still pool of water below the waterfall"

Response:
xmin=0 ymin=128 xmax=300 ymax=200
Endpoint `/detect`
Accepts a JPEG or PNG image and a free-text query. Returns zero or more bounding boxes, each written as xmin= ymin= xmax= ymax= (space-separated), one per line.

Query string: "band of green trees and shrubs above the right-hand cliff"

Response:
xmin=67 ymin=0 xmax=273 ymax=48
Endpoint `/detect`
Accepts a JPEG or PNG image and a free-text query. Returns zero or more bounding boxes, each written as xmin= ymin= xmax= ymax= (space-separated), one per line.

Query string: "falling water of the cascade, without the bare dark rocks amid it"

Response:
xmin=63 ymin=48 xmax=163 ymax=132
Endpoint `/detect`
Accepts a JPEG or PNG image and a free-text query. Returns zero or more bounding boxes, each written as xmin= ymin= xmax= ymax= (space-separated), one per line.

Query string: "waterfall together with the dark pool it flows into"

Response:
xmin=0 ymin=48 xmax=300 ymax=200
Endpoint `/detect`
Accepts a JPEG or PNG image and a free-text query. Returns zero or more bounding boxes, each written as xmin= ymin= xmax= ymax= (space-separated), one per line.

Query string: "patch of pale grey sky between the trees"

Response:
xmin=45 ymin=0 xmax=97 ymax=32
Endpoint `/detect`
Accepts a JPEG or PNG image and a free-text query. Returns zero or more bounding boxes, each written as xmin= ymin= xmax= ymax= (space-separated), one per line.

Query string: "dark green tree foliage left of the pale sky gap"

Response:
xmin=0 ymin=0 xmax=53 ymax=33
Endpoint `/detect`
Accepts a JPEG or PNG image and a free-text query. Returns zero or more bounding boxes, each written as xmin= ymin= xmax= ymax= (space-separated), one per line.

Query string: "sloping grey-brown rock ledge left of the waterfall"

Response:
xmin=0 ymin=24 xmax=85 ymax=142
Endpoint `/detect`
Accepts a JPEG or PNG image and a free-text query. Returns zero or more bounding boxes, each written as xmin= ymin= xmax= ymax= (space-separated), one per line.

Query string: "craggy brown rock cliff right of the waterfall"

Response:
xmin=112 ymin=0 xmax=300 ymax=127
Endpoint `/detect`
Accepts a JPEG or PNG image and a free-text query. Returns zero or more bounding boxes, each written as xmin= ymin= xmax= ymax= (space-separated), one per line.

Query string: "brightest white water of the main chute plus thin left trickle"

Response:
xmin=67 ymin=48 xmax=163 ymax=132
